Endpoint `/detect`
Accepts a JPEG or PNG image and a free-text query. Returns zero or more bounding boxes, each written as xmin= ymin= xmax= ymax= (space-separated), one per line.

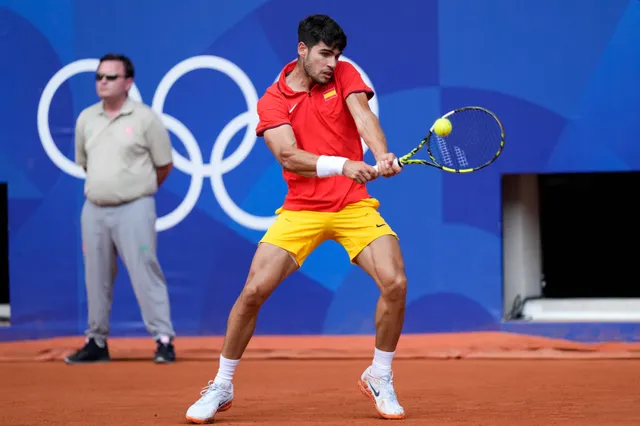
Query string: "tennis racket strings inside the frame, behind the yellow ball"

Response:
xmin=429 ymin=109 xmax=502 ymax=170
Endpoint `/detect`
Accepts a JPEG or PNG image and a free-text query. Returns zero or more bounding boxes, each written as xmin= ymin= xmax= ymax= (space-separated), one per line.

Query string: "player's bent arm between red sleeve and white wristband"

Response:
xmin=264 ymin=124 xmax=320 ymax=177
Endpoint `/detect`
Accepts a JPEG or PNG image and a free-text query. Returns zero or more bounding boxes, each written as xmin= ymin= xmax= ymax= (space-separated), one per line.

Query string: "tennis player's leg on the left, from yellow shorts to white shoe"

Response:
xmin=186 ymin=207 xmax=325 ymax=423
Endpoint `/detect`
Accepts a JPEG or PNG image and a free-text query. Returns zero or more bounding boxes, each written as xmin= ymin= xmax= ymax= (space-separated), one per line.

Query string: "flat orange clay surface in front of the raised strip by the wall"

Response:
xmin=0 ymin=360 xmax=640 ymax=426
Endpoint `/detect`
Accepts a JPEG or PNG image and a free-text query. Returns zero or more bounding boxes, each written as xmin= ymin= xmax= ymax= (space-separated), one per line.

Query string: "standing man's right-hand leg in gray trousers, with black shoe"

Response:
xmin=113 ymin=197 xmax=175 ymax=363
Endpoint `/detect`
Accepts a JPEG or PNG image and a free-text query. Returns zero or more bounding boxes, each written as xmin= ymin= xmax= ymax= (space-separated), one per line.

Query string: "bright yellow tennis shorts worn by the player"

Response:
xmin=260 ymin=198 xmax=398 ymax=266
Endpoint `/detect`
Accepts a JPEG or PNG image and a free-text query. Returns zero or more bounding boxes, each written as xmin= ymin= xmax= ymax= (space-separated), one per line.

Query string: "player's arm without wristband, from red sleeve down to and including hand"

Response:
xmin=345 ymin=92 xmax=400 ymax=177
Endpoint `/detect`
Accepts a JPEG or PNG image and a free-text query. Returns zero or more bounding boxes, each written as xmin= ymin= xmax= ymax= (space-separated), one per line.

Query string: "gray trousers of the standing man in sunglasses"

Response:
xmin=81 ymin=197 xmax=175 ymax=342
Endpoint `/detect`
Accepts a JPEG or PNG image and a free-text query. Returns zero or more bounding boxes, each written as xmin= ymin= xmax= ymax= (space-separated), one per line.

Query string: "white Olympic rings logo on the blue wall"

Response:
xmin=37 ymin=55 xmax=379 ymax=231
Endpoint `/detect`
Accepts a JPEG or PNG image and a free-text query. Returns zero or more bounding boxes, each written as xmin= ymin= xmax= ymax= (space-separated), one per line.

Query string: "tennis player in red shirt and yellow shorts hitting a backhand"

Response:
xmin=186 ymin=15 xmax=407 ymax=423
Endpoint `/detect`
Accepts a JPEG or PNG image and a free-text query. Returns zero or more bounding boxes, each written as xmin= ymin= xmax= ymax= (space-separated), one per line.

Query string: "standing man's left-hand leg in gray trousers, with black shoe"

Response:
xmin=65 ymin=201 xmax=118 ymax=364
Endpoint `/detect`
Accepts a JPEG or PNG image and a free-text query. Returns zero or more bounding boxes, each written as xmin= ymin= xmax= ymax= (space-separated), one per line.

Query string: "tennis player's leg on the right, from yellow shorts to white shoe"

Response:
xmin=334 ymin=200 xmax=407 ymax=419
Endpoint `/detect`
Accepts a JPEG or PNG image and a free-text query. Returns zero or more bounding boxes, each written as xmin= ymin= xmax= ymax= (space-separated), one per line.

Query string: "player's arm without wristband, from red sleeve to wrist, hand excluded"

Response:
xmin=346 ymin=92 xmax=387 ymax=160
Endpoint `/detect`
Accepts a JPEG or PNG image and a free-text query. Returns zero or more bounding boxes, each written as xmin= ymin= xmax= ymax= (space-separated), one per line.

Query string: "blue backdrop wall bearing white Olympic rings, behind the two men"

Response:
xmin=0 ymin=0 xmax=640 ymax=337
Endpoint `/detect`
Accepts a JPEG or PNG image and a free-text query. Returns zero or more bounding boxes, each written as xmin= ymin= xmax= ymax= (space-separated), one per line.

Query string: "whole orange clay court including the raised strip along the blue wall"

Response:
xmin=0 ymin=333 xmax=640 ymax=426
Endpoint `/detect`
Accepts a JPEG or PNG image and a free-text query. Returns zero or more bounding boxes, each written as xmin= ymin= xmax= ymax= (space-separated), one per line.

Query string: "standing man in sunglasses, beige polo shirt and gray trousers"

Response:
xmin=65 ymin=54 xmax=175 ymax=364
